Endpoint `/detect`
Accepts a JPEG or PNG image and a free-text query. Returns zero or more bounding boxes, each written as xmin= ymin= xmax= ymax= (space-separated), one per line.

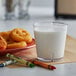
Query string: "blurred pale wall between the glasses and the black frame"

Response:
xmin=29 ymin=0 xmax=55 ymax=18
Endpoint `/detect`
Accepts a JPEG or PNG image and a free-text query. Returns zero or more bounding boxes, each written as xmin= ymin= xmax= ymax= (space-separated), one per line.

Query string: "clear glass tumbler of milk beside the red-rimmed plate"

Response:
xmin=33 ymin=21 xmax=67 ymax=61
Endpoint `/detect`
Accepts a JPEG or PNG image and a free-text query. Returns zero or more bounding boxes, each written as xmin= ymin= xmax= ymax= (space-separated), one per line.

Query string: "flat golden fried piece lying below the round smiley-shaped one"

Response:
xmin=7 ymin=41 xmax=27 ymax=49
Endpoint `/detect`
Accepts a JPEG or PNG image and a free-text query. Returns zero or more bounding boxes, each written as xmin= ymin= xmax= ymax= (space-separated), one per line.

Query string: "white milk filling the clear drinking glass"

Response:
xmin=34 ymin=29 xmax=66 ymax=59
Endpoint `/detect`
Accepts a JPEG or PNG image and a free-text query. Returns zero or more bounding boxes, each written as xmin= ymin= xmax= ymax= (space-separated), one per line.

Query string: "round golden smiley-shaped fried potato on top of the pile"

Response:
xmin=10 ymin=28 xmax=32 ymax=43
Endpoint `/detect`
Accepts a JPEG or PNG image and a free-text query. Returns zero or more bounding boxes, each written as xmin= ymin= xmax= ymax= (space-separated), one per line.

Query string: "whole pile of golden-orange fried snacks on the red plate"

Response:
xmin=0 ymin=28 xmax=32 ymax=50
